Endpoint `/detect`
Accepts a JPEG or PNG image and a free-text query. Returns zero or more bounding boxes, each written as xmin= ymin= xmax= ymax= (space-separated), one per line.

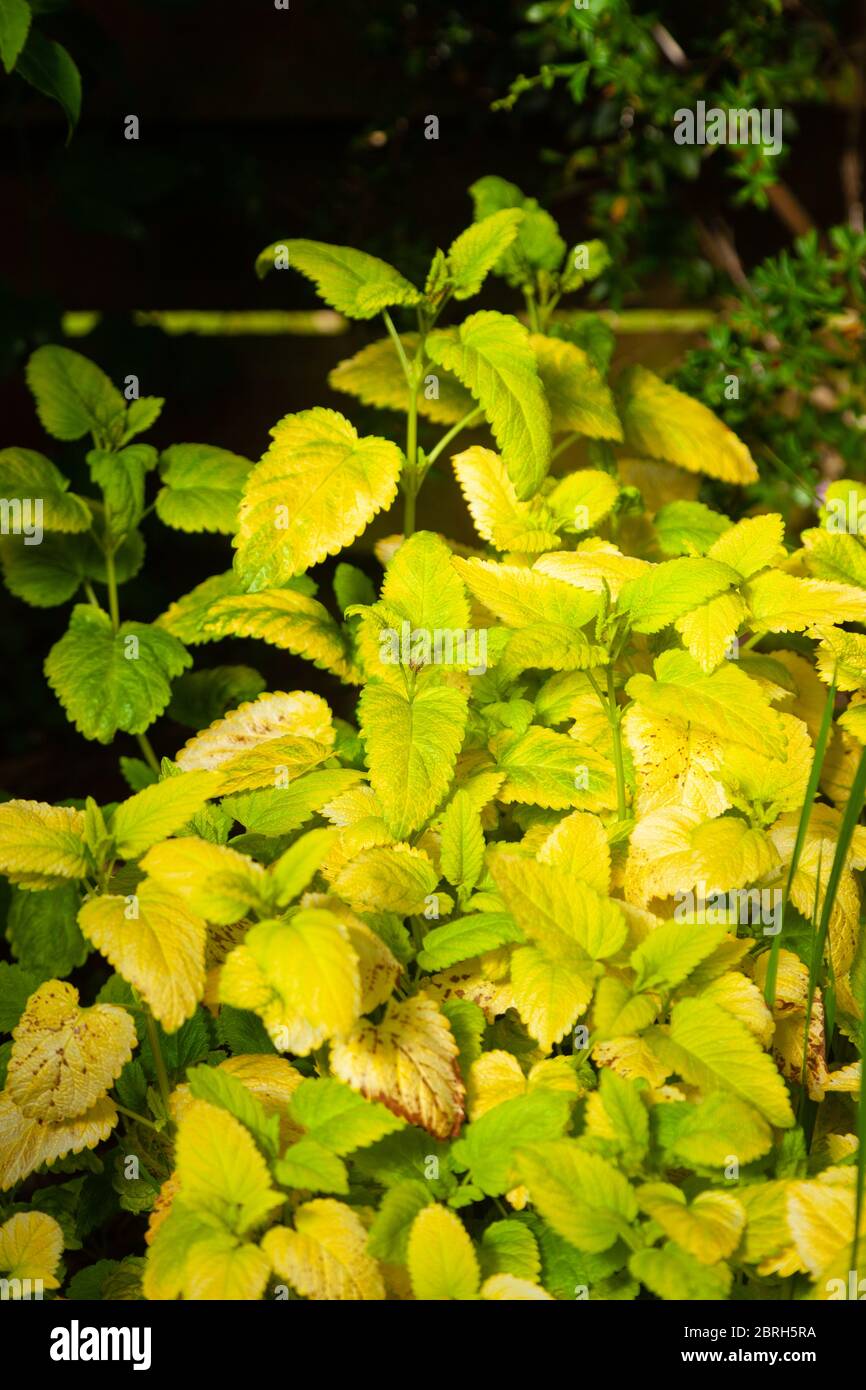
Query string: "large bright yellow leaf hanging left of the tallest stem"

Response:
xmin=234 ymin=407 xmax=403 ymax=592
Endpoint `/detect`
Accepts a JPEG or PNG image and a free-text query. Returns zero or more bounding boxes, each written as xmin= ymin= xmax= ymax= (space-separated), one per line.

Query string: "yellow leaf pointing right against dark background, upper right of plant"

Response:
xmin=617 ymin=367 xmax=758 ymax=484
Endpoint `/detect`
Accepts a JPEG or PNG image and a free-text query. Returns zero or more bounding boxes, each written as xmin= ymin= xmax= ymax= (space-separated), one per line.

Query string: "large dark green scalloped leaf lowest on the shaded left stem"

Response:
xmin=44 ymin=603 xmax=192 ymax=744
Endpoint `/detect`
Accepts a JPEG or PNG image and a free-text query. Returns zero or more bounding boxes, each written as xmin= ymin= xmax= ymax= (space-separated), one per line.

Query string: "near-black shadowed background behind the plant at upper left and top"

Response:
xmin=0 ymin=0 xmax=844 ymax=801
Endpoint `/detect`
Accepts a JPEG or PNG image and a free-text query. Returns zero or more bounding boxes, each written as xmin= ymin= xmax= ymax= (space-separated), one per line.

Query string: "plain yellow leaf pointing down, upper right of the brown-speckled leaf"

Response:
xmin=78 ymin=878 xmax=207 ymax=1033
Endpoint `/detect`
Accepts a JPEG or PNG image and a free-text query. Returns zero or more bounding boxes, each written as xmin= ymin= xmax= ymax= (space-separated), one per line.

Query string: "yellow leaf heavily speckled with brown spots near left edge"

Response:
xmin=6 ymin=980 xmax=136 ymax=1125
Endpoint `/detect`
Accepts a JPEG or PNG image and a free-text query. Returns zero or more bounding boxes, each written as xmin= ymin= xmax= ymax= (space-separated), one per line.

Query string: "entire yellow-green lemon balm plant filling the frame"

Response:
xmin=0 ymin=178 xmax=866 ymax=1300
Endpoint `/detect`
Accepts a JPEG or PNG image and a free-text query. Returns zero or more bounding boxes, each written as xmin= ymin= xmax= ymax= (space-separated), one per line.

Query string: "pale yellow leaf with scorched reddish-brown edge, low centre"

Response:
xmin=331 ymin=994 xmax=464 ymax=1138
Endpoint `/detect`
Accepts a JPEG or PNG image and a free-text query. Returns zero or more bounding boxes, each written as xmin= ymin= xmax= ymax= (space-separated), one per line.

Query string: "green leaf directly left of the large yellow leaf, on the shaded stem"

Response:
xmin=156 ymin=443 xmax=253 ymax=535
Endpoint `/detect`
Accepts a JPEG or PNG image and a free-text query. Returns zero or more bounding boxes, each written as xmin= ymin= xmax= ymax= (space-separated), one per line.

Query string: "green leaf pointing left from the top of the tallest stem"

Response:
xmin=256 ymin=240 xmax=421 ymax=318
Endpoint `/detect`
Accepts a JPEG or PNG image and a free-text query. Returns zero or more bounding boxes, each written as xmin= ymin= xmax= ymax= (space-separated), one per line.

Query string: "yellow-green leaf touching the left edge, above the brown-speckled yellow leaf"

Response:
xmin=0 ymin=801 xmax=89 ymax=888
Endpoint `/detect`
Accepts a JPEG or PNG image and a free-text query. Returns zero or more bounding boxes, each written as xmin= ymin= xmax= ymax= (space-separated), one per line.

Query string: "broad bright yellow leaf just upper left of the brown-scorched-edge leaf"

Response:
xmin=220 ymin=908 xmax=361 ymax=1056
